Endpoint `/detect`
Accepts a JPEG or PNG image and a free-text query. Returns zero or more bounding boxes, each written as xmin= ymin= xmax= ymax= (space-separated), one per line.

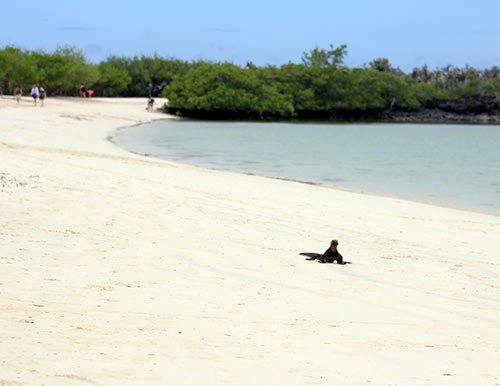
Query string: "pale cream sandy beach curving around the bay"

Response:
xmin=0 ymin=98 xmax=500 ymax=386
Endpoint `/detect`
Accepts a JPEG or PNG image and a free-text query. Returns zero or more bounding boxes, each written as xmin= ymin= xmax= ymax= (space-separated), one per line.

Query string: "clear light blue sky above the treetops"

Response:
xmin=0 ymin=0 xmax=500 ymax=72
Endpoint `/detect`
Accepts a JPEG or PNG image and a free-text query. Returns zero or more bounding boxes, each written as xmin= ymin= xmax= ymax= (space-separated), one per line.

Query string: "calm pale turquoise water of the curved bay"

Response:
xmin=115 ymin=121 xmax=500 ymax=215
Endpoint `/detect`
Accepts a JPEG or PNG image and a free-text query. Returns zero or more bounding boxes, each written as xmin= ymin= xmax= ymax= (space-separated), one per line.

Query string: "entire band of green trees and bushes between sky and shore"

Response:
xmin=0 ymin=45 xmax=500 ymax=119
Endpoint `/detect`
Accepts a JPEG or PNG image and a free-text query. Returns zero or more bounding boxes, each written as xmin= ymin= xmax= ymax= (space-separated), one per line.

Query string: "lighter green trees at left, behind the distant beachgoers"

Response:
xmin=0 ymin=46 xmax=189 ymax=97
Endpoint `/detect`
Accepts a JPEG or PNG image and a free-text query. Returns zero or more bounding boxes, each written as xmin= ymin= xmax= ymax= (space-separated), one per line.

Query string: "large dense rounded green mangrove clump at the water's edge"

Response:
xmin=163 ymin=63 xmax=420 ymax=118
